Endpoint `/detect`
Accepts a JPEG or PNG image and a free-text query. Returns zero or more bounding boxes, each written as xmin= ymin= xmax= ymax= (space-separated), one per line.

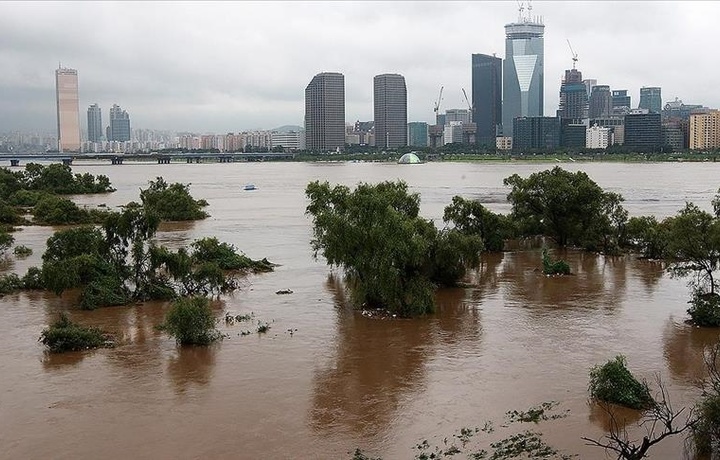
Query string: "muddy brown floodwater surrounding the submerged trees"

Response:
xmin=0 ymin=163 xmax=720 ymax=460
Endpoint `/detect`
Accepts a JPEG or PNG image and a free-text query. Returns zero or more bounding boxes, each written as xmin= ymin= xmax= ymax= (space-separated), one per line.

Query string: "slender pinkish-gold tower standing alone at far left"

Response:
xmin=55 ymin=67 xmax=80 ymax=152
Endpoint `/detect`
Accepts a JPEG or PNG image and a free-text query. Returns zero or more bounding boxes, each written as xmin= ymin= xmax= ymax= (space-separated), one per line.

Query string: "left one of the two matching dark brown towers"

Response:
xmin=305 ymin=72 xmax=345 ymax=151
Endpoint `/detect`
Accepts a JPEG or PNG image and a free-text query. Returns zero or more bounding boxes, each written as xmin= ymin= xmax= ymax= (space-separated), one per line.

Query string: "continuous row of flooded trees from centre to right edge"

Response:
xmin=306 ymin=167 xmax=720 ymax=326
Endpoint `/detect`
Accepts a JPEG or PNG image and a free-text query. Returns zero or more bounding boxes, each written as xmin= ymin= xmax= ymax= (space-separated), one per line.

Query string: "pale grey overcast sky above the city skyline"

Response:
xmin=0 ymin=1 xmax=720 ymax=133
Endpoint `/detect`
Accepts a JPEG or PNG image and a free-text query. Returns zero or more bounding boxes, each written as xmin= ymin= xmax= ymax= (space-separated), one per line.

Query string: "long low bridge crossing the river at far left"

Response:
xmin=0 ymin=152 xmax=295 ymax=166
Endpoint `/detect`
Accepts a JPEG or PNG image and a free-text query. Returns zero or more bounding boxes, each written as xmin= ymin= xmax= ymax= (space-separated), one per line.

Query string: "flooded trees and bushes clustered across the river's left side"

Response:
xmin=0 ymin=167 xmax=274 ymax=352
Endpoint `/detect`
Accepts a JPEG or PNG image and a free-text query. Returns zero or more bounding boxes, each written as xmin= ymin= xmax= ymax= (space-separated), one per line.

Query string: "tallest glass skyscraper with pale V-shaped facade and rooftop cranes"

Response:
xmin=502 ymin=9 xmax=545 ymax=136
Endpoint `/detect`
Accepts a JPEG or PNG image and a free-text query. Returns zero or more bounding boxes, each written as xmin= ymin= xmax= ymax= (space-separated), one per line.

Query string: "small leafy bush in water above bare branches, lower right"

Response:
xmin=589 ymin=355 xmax=655 ymax=410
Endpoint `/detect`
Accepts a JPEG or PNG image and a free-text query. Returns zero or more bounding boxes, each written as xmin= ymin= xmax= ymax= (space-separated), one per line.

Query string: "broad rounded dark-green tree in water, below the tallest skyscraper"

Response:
xmin=503 ymin=166 xmax=627 ymax=251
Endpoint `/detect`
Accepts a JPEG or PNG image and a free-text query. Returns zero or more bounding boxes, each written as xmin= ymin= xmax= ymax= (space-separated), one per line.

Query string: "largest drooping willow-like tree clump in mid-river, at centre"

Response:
xmin=305 ymin=181 xmax=482 ymax=316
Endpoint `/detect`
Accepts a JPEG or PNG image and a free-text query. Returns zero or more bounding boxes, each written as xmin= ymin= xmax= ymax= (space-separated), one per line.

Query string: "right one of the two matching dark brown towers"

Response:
xmin=373 ymin=73 xmax=408 ymax=148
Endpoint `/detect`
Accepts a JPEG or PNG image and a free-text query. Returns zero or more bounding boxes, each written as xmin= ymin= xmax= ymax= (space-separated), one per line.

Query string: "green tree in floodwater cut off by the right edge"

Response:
xmin=666 ymin=203 xmax=720 ymax=294
